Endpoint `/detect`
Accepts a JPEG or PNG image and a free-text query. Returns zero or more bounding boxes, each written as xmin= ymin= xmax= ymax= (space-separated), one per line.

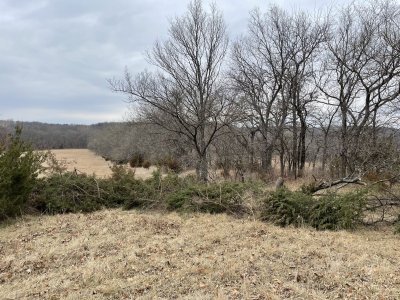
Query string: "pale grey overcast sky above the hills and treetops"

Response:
xmin=0 ymin=0 xmax=349 ymax=124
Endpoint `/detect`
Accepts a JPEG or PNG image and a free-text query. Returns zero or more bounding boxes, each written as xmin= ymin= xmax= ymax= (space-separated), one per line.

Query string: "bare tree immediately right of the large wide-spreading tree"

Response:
xmin=230 ymin=6 xmax=290 ymax=172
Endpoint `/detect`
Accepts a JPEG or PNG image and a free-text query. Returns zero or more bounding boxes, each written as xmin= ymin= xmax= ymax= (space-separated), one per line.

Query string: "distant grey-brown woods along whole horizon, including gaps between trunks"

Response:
xmin=0 ymin=121 xmax=400 ymax=178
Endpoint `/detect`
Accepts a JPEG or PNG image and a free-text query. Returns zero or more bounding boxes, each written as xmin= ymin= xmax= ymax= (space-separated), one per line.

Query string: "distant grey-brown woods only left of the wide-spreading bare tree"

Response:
xmin=0 ymin=120 xmax=186 ymax=163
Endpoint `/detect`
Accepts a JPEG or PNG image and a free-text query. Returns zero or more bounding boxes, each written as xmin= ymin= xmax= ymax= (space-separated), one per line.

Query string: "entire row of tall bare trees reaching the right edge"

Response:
xmin=109 ymin=0 xmax=400 ymax=181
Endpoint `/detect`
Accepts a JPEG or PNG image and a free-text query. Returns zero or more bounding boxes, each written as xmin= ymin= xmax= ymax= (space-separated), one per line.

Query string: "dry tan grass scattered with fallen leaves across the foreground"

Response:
xmin=0 ymin=210 xmax=400 ymax=299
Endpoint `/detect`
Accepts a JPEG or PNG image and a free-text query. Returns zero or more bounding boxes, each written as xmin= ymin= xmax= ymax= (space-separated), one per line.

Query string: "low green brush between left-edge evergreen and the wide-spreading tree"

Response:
xmin=30 ymin=165 xmax=180 ymax=214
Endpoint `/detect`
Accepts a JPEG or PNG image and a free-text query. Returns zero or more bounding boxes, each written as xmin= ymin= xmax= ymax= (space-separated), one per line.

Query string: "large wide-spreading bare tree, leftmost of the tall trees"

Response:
xmin=110 ymin=0 xmax=233 ymax=181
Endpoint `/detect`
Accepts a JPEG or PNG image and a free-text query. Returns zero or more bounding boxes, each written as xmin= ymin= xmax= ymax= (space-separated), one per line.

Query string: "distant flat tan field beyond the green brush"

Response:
xmin=43 ymin=149 xmax=156 ymax=179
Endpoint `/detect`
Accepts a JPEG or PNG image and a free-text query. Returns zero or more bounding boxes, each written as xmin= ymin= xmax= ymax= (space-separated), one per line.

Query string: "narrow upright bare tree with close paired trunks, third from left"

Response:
xmin=286 ymin=12 xmax=328 ymax=178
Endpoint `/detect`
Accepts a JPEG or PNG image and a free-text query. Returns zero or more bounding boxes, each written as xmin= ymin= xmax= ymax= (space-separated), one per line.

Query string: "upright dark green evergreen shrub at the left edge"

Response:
xmin=0 ymin=127 xmax=45 ymax=220
